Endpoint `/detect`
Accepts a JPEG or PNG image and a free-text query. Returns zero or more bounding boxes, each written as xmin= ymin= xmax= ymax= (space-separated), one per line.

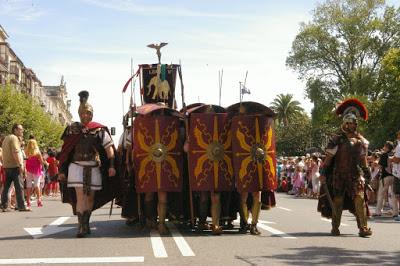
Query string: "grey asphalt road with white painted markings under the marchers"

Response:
xmin=0 ymin=194 xmax=400 ymax=265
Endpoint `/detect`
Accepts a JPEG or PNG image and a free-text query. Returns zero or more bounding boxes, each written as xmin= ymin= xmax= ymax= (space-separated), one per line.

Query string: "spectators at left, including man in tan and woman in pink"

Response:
xmin=0 ymin=124 xmax=59 ymax=212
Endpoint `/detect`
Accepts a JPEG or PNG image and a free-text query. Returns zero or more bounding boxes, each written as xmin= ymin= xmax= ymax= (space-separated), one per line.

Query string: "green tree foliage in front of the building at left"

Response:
xmin=0 ymin=85 xmax=64 ymax=148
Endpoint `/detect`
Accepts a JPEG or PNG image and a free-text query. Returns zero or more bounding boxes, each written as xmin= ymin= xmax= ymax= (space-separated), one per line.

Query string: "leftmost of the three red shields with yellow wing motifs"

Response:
xmin=133 ymin=115 xmax=183 ymax=193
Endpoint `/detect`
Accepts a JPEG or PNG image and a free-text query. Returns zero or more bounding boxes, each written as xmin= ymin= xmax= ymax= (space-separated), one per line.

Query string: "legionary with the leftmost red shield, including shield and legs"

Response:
xmin=133 ymin=103 xmax=184 ymax=234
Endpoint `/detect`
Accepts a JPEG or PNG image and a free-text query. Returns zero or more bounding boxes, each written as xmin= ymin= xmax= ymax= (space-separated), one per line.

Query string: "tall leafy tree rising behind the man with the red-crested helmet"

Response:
xmin=286 ymin=0 xmax=400 ymax=149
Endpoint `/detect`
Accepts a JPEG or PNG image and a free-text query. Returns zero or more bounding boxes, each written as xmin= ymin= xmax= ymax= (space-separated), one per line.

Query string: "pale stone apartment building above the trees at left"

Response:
xmin=0 ymin=25 xmax=72 ymax=125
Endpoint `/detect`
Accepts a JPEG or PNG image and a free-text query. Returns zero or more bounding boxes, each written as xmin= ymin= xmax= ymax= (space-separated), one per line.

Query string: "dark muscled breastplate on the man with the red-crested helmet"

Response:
xmin=334 ymin=136 xmax=363 ymax=177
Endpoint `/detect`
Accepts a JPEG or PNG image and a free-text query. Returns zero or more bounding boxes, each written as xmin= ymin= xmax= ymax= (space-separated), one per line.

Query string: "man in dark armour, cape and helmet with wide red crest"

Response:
xmin=318 ymin=99 xmax=372 ymax=237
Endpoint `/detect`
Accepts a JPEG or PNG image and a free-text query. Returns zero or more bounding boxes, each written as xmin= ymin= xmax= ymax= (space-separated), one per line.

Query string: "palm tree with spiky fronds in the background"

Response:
xmin=271 ymin=93 xmax=304 ymax=126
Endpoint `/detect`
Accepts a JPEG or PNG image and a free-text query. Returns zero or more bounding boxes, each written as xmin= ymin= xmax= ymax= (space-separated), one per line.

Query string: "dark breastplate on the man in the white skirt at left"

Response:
xmin=72 ymin=129 xmax=100 ymax=161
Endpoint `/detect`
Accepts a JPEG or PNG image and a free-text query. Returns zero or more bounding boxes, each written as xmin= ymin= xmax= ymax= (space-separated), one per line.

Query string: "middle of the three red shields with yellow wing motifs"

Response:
xmin=188 ymin=113 xmax=234 ymax=191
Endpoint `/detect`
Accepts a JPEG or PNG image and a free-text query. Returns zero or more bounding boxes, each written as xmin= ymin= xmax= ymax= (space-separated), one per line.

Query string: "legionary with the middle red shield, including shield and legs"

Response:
xmin=185 ymin=104 xmax=234 ymax=235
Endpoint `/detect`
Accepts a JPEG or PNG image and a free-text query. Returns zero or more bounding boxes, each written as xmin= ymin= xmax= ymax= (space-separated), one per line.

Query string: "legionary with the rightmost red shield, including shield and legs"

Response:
xmin=227 ymin=102 xmax=277 ymax=235
